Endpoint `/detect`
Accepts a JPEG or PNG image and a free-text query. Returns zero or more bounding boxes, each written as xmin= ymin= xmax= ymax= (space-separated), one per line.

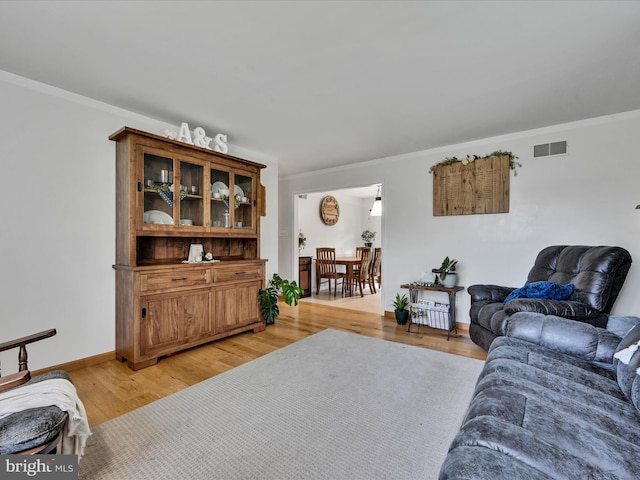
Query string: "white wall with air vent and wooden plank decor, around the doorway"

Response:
xmin=279 ymin=111 xmax=640 ymax=322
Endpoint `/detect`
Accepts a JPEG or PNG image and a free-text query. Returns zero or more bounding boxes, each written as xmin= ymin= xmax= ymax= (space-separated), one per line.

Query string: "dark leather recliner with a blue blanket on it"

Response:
xmin=467 ymin=245 xmax=631 ymax=350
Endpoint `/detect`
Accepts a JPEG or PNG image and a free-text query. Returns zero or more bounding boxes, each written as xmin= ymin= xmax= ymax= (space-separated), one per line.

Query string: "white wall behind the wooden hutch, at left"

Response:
xmin=0 ymin=71 xmax=278 ymax=373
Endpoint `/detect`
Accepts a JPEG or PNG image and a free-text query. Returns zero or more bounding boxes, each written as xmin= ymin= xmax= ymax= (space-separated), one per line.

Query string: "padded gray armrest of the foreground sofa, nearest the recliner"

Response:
xmin=505 ymin=312 xmax=621 ymax=364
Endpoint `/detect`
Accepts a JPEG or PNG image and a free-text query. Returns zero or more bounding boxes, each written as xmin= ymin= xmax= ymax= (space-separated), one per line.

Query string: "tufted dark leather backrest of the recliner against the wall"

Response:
xmin=527 ymin=245 xmax=631 ymax=313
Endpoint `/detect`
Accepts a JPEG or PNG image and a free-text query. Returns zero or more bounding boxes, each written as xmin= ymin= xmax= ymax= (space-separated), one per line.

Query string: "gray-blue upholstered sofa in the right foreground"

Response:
xmin=439 ymin=313 xmax=640 ymax=480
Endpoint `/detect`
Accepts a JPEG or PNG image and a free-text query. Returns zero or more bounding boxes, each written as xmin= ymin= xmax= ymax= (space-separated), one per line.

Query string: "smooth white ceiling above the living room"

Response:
xmin=0 ymin=0 xmax=640 ymax=175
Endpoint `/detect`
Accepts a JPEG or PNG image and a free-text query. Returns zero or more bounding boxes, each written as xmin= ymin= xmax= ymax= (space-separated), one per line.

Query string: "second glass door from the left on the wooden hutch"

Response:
xmin=174 ymin=161 xmax=205 ymax=227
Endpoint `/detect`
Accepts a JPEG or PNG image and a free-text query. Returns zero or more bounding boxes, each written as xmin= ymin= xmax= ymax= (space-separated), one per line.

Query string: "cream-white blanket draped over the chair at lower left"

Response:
xmin=0 ymin=378 xmax=91 ymax=457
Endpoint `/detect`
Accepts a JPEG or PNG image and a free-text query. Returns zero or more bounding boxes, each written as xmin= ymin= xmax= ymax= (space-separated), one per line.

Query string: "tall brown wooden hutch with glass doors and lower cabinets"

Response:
xmin=109 ymin=127 xmax=266 ymax=370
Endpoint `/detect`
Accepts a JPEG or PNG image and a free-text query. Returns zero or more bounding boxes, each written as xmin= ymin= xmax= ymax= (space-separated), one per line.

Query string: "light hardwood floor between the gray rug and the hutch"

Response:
xmin=69 ymin=302 xmax=486 ymax=426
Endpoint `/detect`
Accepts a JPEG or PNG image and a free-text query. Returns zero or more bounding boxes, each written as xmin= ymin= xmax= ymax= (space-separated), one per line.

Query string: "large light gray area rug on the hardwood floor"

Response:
xmin=79 ymin=329 xmax=483 ymax=480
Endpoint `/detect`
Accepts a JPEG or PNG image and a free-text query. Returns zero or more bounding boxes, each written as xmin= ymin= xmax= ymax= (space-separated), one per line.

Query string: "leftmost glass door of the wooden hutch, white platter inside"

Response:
xmin=143 ymin=152 xmax=174 ymax=225
